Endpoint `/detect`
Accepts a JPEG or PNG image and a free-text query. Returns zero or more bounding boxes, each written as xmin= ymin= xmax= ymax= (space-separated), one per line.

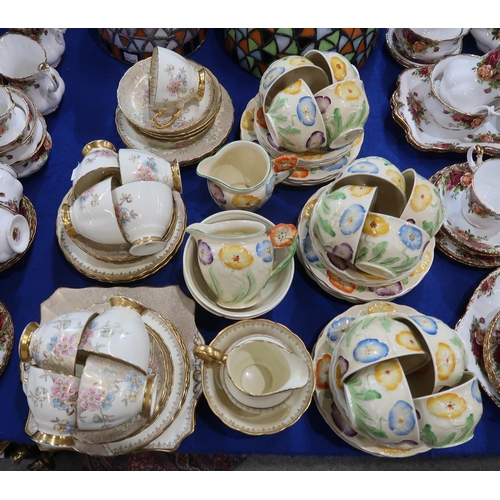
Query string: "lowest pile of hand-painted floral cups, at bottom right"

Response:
xmin=322 ymin=311 xmax=483 ymax=452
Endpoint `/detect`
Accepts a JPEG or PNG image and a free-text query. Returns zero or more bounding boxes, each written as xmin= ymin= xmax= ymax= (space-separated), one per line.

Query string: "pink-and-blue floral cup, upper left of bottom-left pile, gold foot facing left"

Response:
xmin=19 ymin=311 xmax=97 ymax=375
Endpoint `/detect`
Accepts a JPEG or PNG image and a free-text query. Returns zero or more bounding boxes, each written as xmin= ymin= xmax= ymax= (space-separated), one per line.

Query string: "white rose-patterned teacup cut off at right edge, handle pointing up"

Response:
xmin=461 ymin=147 xmax=500 ymax=232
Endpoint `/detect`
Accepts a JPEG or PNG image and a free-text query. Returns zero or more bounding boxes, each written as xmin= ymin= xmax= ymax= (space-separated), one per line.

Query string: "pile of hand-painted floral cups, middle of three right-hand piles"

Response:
xmin=299 ymin=156 xmax=445 ymax=300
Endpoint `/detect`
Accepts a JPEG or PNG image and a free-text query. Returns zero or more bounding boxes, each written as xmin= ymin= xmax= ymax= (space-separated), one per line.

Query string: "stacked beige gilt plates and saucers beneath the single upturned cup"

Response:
xmin=115 ymin=58 xmax=234 ymax=165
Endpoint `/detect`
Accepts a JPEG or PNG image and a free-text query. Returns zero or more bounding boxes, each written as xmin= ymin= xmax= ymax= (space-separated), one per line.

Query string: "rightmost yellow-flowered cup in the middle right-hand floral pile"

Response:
xmin=400 ymin=168 xmax=445 ymax=238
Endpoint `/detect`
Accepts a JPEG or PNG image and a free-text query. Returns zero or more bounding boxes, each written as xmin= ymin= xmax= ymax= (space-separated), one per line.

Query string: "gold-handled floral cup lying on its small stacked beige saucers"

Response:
xmin=117 ymin=47 xmax=222 ymax=149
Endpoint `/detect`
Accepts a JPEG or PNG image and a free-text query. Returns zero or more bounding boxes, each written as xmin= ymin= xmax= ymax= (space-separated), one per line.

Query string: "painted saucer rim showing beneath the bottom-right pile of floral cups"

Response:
xmin=312 ymin=302 xmax=430 ymax=458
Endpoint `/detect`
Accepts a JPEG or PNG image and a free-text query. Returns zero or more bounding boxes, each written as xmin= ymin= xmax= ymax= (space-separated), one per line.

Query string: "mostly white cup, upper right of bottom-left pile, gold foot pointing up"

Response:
xmin=79 ymin=297 xmax=149 ymax=373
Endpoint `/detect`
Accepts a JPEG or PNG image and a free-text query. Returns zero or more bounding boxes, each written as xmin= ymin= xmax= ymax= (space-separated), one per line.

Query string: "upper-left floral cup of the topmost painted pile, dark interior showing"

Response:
xmin=259 ymin=55 xmax=329 ymax=111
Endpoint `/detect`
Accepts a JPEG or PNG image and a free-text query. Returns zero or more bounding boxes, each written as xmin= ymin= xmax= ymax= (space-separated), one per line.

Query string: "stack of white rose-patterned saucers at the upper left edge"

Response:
xmin=0 ymin=86 xmax=52 ymax=178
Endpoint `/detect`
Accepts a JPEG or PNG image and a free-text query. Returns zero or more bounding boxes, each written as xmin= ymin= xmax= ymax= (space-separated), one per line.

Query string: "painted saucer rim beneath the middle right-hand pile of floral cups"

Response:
xmin=297 ymin=187 xmax=435 ymax=304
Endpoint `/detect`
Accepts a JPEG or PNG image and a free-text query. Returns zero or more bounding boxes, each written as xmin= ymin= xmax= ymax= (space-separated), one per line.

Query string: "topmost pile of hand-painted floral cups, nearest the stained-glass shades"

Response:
xmin=250 ymin=50 xmax=370 ymax=183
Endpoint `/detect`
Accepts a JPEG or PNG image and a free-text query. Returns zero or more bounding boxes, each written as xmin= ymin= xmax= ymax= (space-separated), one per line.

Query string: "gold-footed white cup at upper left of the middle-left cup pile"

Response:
xmin=71 ymin=141 xmax=120 ymax=198
